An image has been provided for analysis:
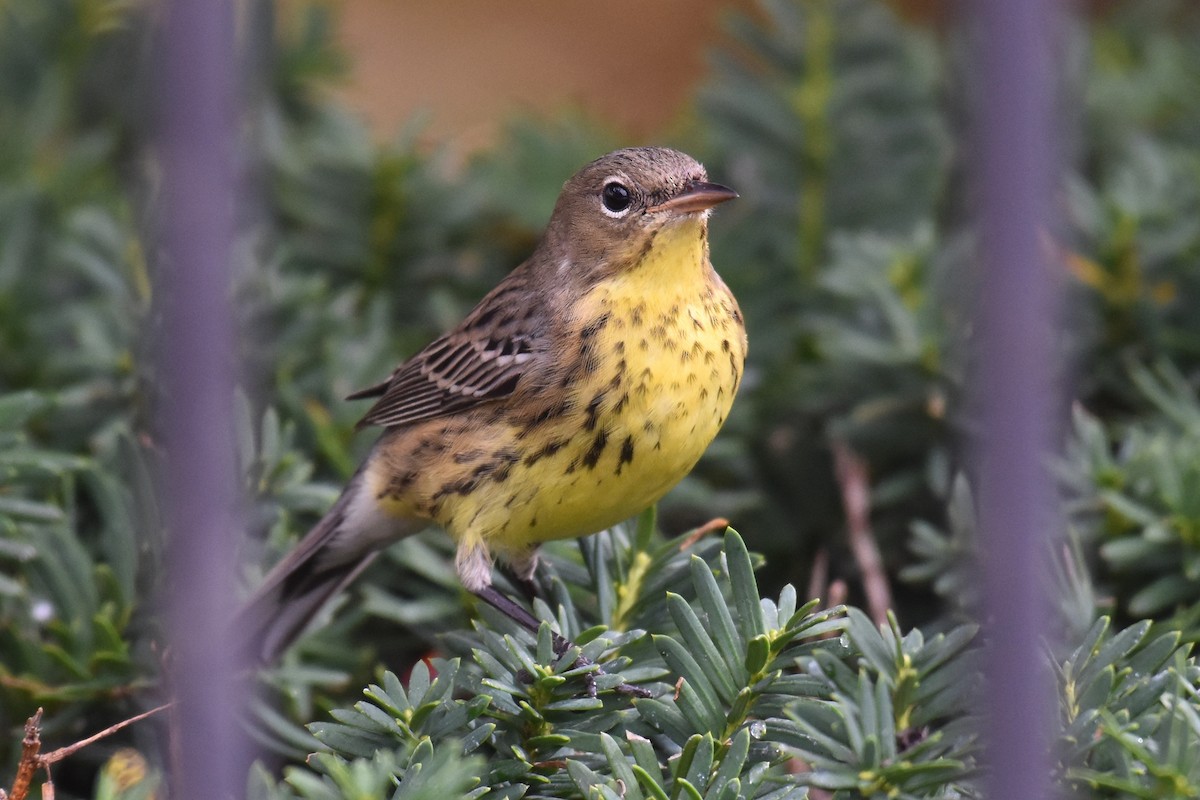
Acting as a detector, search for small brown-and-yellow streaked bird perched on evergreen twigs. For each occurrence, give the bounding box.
[238,148,746,662]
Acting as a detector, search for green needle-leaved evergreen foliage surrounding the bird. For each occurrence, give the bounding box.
[0,0,1200,800]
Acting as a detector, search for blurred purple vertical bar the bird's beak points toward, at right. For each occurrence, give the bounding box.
[968,0,1062,800]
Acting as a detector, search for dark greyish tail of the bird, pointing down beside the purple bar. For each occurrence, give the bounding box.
[234,474,413,664]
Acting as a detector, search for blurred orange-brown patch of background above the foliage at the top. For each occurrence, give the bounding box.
[293,0,940,150]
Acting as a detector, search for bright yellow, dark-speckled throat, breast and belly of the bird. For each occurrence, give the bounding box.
[372,219,746,555]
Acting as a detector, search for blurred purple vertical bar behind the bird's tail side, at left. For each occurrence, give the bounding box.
[157,0,246,798]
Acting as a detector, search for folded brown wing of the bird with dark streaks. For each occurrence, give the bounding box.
[349,276,546,428]
